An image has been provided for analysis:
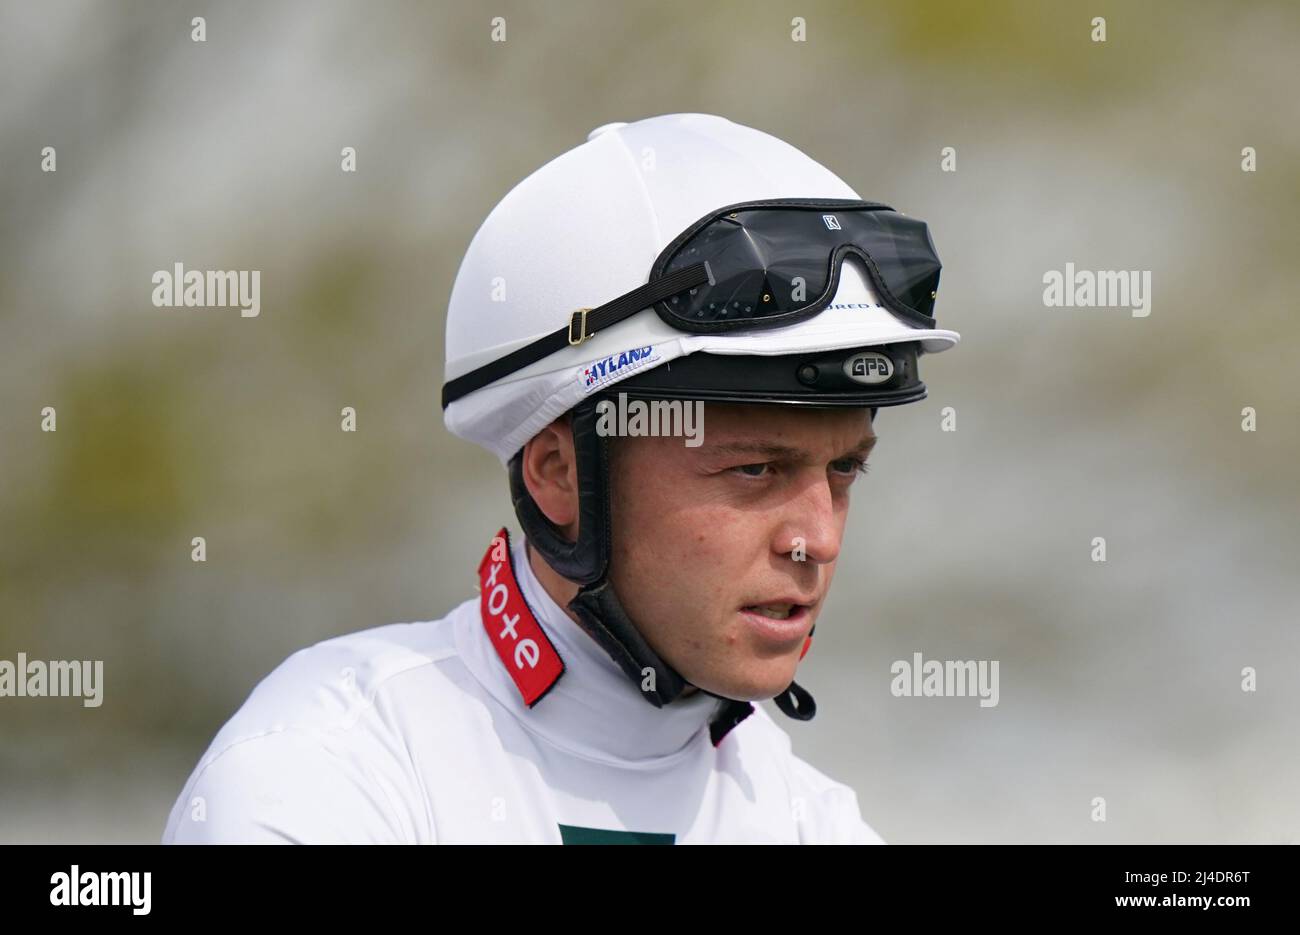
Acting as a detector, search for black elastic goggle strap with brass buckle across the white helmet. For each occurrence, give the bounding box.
[442,263,711,408]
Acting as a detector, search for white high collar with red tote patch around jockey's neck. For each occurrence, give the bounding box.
[456,529,724,766]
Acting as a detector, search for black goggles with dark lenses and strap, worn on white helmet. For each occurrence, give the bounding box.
[442,198,941,408]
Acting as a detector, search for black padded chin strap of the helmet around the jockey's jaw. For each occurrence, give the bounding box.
[510,395,816,745]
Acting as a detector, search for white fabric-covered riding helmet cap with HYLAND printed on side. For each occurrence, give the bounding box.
[443,113,961,463]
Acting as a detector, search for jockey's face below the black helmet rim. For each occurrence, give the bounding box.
[610,404,875,701]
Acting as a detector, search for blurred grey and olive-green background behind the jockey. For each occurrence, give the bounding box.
[0,0,1300,843]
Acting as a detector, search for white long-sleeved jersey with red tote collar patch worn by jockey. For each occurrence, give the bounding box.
[163,530,884,844]
